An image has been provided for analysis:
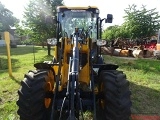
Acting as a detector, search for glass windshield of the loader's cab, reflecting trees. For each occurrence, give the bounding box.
[58,10,97,39]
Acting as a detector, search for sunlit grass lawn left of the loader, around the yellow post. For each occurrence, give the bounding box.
[0,46,51,120]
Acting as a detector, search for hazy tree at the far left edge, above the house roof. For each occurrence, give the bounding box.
[0,2,19,32]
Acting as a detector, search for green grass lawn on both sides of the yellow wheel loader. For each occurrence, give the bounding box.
[0,46,160,120]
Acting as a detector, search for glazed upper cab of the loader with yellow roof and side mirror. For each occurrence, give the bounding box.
[57,6,113,40]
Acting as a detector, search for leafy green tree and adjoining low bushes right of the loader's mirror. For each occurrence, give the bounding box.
[103,4,160,39]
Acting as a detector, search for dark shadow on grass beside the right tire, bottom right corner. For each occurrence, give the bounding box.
[130,82,160,115]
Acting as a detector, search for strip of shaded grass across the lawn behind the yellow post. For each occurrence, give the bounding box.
[0,46,46,55]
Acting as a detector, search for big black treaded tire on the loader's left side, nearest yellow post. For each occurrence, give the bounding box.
[17,70,55,120]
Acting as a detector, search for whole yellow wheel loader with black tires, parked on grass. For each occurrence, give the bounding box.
[17,6,131,120]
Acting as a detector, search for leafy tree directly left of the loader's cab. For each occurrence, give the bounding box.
[23,0,62,46]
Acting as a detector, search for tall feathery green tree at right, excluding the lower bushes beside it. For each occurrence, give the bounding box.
[124,4,160,38]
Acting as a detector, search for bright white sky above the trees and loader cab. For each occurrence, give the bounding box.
[0,0,160,27]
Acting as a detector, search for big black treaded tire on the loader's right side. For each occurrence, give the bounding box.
[100,70,132,120]
